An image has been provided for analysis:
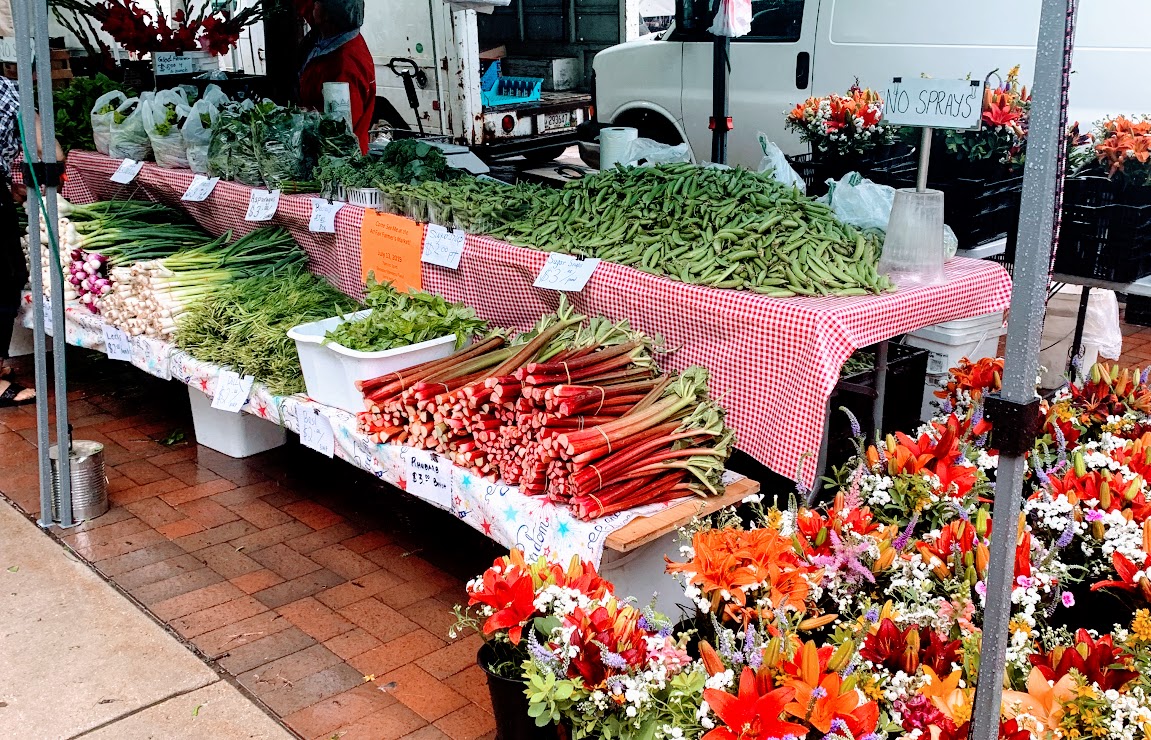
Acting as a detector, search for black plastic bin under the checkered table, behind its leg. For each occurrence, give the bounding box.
[826,341,929,472]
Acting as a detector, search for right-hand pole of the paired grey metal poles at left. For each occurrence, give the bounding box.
[28,0,74,527]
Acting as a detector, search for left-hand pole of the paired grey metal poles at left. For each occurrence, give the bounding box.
[12,0,54,527]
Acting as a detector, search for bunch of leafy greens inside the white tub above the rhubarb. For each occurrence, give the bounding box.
[323,277,487,352]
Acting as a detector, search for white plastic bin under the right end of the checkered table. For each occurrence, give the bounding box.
[904,312,1007,419]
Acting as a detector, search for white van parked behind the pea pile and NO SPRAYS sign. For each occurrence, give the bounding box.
[594,0,1151,167]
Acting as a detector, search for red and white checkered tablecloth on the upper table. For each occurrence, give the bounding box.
[66,152,1011,485]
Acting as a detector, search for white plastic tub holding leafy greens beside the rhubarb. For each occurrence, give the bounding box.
[288,308,456,413]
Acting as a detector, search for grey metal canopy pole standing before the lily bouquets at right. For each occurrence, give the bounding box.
[971,0,1075,740]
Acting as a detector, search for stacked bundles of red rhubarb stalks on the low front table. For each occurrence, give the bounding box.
[358,302,734,519]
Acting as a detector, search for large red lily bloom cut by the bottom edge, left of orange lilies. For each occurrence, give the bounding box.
[703,667,808,740]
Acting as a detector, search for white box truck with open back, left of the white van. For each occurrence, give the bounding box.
[363,0,640,160]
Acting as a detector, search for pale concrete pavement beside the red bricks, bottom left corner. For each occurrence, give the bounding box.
[0,504,295,740]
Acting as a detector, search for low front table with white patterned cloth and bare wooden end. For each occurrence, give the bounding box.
[22,293,760,610]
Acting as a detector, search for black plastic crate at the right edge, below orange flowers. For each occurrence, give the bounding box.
[1055,177,1151,283]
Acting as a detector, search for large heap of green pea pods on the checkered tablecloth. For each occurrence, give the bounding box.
[490,163,892,298]
